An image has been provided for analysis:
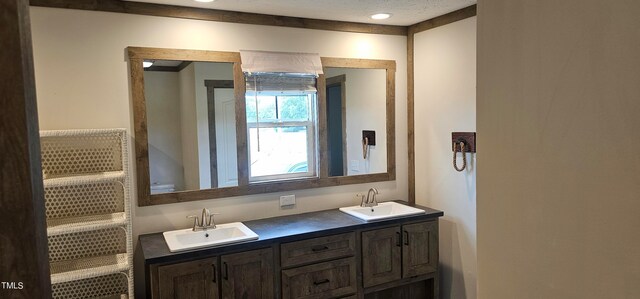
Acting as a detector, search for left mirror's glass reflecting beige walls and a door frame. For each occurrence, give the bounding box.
[144,60,238,194]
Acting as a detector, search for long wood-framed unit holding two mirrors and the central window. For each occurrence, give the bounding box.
[128,47,395,206]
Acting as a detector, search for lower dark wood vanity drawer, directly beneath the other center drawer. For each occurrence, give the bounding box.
[282,257,356,299]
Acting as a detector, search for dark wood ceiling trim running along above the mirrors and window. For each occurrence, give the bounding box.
[29,0,407,36]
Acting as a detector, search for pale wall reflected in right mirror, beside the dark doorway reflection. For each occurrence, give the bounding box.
[326,68,384,175]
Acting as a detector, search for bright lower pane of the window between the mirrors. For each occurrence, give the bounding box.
[249,126,309,177]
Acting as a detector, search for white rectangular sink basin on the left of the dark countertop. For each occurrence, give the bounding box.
[162,222,258,252]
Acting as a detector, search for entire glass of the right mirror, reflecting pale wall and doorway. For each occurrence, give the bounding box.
[325,67,387,176]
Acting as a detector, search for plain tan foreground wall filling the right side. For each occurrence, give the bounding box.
[477,0,640,299]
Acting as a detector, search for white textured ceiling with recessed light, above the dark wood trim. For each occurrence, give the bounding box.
[126,0,477,25]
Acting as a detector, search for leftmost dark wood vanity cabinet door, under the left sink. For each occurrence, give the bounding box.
[157,258,218,299]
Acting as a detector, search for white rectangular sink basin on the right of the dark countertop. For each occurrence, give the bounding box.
[340,202,425,221]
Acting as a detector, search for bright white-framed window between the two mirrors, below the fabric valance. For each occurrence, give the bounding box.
[246,73,317,182]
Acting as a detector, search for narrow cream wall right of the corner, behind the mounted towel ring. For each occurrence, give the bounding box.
[414,17,476,298]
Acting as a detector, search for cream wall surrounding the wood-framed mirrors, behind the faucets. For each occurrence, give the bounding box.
[31,7,407,246]
